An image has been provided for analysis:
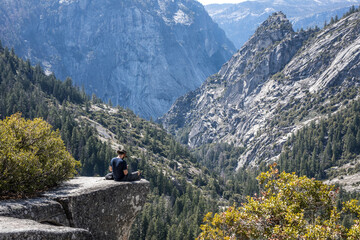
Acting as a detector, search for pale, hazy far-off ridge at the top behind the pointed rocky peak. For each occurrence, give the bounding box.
[205,0,360,49]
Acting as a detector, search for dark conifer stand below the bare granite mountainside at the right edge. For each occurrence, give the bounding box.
[279,94,360,179]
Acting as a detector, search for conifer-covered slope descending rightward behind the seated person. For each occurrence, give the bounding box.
[0,42,225,239]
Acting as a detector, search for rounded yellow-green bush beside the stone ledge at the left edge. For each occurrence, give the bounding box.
[0,113,79,198]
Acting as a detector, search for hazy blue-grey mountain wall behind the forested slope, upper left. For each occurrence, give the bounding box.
[0,0,235,118]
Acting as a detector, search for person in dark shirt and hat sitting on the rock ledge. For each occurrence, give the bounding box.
[105,150,141,182]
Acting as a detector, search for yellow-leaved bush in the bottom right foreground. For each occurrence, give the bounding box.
[198,164,360,239]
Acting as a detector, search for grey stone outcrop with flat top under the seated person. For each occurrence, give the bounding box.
[0,177,149,240]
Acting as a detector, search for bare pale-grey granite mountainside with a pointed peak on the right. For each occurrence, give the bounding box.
[162,12,360,167]
